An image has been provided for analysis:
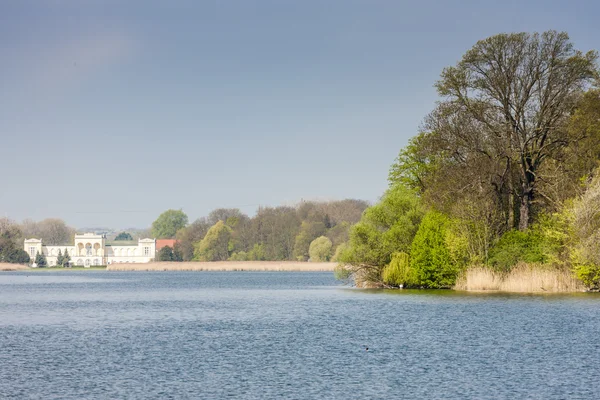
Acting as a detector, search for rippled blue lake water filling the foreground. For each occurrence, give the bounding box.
[0,271,600,399]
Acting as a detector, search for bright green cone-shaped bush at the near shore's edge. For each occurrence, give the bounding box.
[410,211,461,289]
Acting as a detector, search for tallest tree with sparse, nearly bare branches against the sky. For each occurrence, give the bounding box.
[434,31,598,230]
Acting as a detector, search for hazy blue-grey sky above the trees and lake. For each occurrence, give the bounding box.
[0,0,600,228]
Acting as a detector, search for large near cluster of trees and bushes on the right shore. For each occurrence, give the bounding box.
[338,31,600,288]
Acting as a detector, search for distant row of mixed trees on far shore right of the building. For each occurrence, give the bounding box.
[152,199,368,261]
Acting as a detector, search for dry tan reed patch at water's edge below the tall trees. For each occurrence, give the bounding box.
[454,264,585,293]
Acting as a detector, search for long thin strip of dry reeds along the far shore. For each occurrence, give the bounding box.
[106,261,337,272]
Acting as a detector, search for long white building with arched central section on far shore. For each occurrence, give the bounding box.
[24,233,156,267]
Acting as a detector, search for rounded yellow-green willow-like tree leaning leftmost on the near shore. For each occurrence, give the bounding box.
[338,185,424,282]
